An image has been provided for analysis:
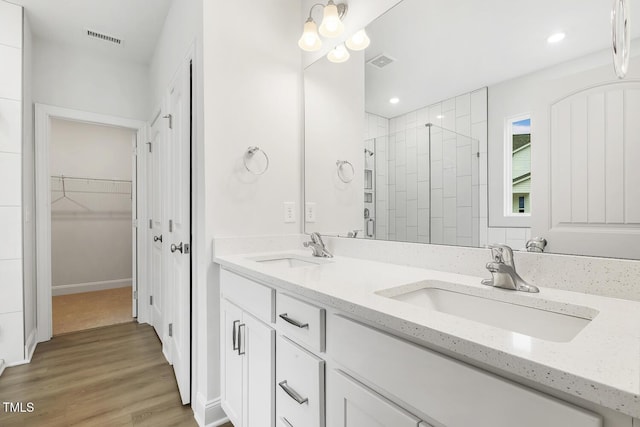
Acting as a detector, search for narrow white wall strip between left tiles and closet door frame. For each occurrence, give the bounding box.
[22,10,36,358]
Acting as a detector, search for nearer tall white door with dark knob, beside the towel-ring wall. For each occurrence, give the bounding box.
[165,61,191,404]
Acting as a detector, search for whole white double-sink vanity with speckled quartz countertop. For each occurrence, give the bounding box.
[215,250,640,427]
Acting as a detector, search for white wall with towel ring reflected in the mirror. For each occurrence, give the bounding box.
[304,52,364,236]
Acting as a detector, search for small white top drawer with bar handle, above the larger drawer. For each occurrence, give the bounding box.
[276,293,325,352]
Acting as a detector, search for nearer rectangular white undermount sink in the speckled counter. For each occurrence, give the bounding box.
[378,282,597,342]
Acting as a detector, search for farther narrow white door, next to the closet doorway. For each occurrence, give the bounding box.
[147,113,164,347]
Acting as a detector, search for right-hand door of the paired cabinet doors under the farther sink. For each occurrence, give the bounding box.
[240,312,276,427]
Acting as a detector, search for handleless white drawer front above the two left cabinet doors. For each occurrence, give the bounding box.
[220,268,275,323]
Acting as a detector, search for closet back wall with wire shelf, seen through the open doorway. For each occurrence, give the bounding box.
[50,119,134,294]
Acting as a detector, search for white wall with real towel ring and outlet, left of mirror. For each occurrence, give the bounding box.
[202,0,302,422]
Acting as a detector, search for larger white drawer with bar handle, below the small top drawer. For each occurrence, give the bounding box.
[276,336,325,427]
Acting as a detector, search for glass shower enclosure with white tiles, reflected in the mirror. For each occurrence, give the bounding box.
[365,124,480,246]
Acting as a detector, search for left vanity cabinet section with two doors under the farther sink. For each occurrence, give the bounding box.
[220,272,275,427]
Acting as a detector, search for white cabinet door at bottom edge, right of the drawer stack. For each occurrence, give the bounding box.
[327,371,427,427]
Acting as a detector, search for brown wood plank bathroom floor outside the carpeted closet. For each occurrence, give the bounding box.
[0,322,197,427]
